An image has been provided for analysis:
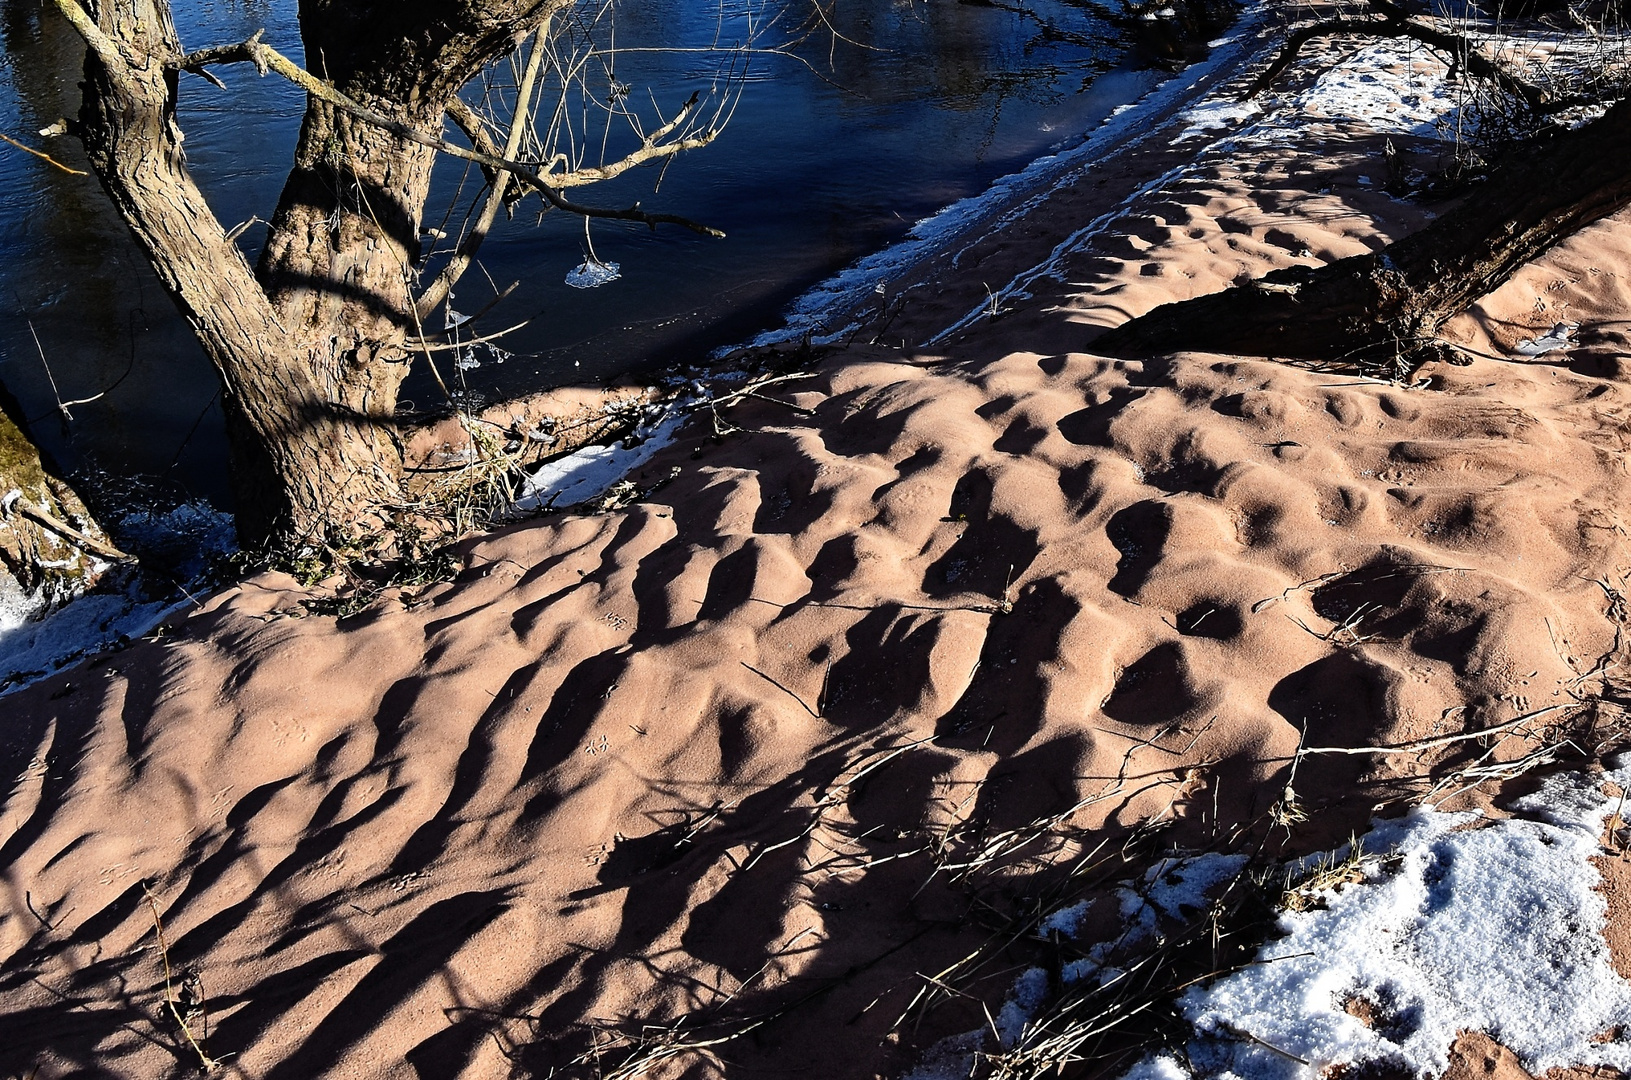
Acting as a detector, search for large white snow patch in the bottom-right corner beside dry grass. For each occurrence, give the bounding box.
[1129,767,1631,1080]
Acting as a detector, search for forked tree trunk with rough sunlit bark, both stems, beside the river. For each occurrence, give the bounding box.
[59,0,571,545]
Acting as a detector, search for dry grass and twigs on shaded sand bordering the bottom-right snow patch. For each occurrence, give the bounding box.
[902,681,1631,1080]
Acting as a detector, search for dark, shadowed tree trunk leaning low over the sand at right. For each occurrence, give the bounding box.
[1093,101,1631,370]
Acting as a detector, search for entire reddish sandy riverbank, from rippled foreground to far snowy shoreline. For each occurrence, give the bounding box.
[0,8,1631,1080]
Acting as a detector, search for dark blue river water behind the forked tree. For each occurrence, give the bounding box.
[0,0,1226,506]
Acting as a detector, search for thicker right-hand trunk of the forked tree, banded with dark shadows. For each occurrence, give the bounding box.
[238,0,569,541]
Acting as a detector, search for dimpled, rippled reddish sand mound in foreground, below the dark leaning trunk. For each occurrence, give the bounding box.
[0,332,1626,1077]
